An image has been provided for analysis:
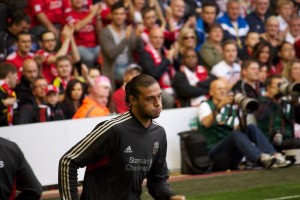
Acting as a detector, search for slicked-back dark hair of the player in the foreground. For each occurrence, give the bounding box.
[125,74,157,107]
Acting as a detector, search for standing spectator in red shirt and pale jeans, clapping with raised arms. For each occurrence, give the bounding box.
[64,0,102,67]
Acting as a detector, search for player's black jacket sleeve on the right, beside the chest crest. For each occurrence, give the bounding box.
[147,132,175,200]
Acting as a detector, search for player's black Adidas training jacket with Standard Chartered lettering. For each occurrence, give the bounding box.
[59,111,174,200]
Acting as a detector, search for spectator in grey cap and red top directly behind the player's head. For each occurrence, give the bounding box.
[112,64,142,114]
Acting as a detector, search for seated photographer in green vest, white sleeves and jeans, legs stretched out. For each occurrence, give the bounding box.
[198,79,290,170]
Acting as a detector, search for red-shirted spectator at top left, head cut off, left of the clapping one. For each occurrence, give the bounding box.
[27,0,70,37]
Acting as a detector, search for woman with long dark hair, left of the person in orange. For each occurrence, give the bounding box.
[62,79,85,119]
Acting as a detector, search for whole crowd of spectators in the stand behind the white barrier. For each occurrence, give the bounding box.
[0,0,300,152]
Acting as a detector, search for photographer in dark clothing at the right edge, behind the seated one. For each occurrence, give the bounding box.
[255,75,300,151]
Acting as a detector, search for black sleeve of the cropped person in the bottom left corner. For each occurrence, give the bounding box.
[16,147,43,200]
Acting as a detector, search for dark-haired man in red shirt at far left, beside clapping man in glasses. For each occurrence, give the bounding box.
[6,32,34,80]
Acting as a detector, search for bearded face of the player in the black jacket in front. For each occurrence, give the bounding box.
[131,83,162,120]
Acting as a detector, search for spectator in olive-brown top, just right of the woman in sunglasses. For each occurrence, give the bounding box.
[199,24,223,69]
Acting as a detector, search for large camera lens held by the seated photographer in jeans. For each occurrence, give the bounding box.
[233,93,259,113]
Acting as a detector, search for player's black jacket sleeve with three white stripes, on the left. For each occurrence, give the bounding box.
[58,121,116,200]
